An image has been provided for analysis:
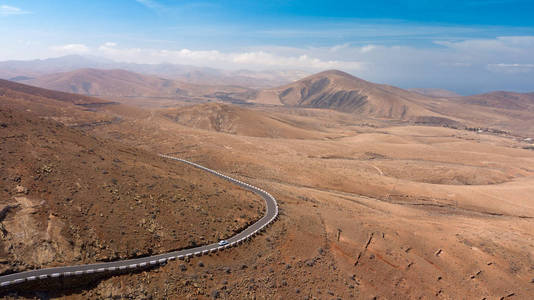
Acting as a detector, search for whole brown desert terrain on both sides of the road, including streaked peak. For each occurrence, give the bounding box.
[0,71,534,299]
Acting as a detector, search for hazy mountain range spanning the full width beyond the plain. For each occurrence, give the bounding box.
[2,57,534,134]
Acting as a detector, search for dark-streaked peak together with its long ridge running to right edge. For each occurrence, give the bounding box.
[252,70,534,135]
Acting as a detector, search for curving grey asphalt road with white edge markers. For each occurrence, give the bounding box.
[0,154,278,289]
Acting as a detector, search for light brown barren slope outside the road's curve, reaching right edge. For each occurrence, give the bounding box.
[79,107,534,299]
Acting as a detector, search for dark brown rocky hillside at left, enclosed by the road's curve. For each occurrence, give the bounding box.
[0,82,263,273]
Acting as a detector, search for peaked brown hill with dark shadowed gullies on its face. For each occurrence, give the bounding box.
[255,70,438,119]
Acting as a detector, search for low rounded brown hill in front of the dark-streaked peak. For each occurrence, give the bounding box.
[160,103,321,139]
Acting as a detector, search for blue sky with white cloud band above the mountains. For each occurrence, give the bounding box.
[0,0,534,94]
